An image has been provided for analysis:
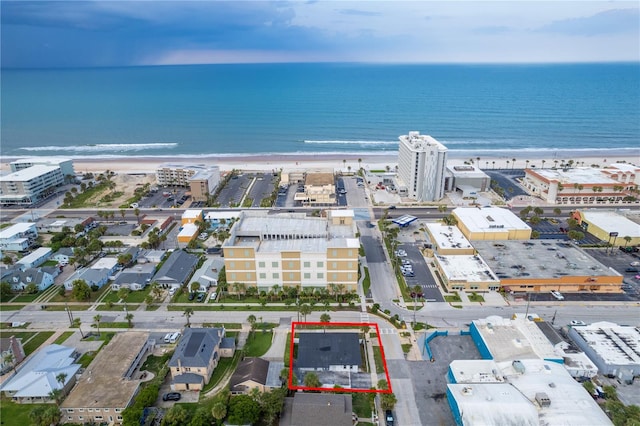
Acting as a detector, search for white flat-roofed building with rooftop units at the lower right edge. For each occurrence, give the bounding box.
[569,321,640,380]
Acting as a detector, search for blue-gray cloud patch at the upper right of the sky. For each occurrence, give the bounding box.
[537,9,640,37]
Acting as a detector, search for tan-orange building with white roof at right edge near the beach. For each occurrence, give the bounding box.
[522,163,640,205]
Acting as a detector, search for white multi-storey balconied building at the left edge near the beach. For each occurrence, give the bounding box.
[0,164,65,206]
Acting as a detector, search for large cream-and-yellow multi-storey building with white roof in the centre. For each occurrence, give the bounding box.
[222,210,360,293]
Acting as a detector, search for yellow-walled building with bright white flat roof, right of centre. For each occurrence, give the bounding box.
[451,207,531,241]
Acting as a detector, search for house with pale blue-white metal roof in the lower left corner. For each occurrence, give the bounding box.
[0,344,81,403]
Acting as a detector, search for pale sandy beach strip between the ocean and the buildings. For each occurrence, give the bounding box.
[0,148,640,173]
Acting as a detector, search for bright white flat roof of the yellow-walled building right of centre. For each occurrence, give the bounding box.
[452,207,531,232]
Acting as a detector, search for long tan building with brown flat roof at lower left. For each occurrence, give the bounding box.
[60,331,153,424]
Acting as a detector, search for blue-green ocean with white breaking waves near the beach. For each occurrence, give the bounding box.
[0,63,640,158]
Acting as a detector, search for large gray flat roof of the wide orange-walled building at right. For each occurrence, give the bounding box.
[473,240,620,279]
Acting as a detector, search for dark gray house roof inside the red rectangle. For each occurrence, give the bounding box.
[295,333,362,372]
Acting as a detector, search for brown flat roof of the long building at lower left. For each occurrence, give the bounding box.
[61,331,149,408]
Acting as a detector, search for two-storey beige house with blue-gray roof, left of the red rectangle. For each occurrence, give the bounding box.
[169,328,233,391]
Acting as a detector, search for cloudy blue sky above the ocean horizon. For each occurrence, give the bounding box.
[0,0,640,68]
